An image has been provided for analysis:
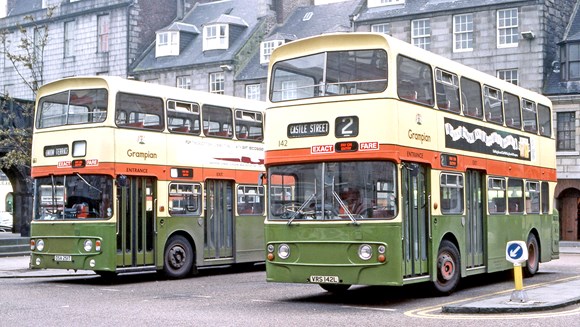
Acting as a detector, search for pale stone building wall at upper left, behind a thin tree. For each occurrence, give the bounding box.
[0,0,192,99]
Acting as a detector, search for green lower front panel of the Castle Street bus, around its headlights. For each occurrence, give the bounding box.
[266,224,403,285]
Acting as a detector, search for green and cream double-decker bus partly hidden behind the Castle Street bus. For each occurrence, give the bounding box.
[30,76,265,278]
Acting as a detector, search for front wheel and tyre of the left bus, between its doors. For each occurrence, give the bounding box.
[163,235,194,279]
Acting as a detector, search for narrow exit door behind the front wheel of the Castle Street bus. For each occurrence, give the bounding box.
[465,170,485,268]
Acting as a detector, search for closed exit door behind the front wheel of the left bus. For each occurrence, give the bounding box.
[204,180,234,259]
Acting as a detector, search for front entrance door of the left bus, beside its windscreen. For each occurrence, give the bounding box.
[117,176,157,267]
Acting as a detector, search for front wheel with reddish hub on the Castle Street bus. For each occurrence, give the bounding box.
[433,240,461,294]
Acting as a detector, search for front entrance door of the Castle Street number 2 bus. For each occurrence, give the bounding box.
[401,162,429,278]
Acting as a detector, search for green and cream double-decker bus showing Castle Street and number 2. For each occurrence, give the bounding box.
[265,33,559,293]
